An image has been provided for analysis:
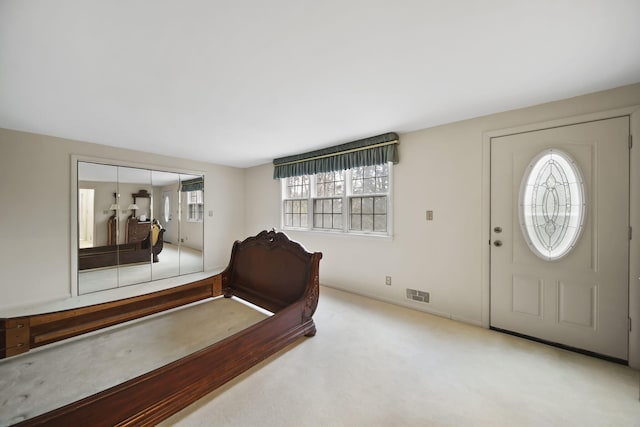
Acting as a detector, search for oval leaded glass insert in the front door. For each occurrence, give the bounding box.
[519,148,585,261]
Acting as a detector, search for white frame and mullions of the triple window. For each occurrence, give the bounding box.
[280,162,393,237]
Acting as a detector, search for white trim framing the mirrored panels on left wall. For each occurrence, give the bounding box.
[69,154,207,298]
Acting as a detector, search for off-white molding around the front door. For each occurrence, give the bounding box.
[480,105,640,369]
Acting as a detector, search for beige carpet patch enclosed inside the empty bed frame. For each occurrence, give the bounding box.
[0,297,268,426]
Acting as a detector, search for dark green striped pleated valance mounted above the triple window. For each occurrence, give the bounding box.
[273,132,399,179]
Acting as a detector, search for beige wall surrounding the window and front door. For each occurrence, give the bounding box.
[245,84,640,364]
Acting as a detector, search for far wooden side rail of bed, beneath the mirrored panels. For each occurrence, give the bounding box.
[0,274,222,359]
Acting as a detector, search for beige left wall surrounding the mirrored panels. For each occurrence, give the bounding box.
[0,129,244,309]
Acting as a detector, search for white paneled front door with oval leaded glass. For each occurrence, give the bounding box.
[490,117,629,360]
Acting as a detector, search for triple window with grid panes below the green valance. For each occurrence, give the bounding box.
[282,163,392,235]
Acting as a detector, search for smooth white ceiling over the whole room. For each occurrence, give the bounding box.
[0,0,640,167]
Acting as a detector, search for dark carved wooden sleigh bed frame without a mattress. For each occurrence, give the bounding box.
[0,231,322,426]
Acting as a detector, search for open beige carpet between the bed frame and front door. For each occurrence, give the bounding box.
[163,287,640,427]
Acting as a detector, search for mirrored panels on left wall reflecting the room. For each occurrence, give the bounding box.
[77,161,204,294]
